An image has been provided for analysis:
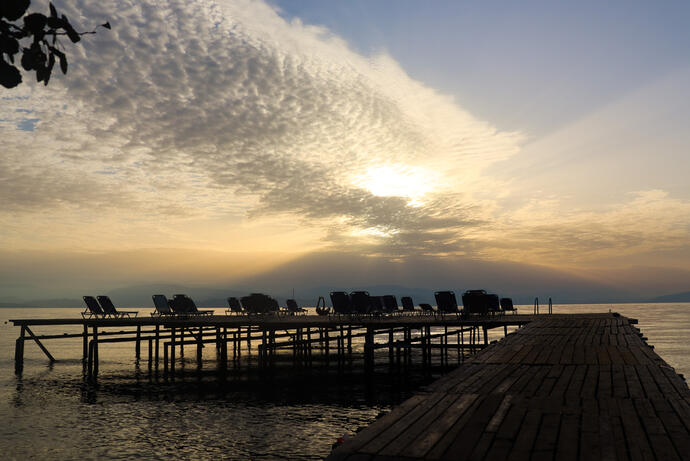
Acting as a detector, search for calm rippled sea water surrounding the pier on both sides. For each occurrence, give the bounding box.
[0,303,690,460]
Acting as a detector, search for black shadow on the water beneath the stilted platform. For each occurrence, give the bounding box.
[79,348,453,407]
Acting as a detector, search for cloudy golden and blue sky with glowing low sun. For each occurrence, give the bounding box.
[0,0,690,300]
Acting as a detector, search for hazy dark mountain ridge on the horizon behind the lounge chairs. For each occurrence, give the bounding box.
[0,253,690,308]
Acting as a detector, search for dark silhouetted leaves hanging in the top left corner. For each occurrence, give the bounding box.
[0,0,110,88]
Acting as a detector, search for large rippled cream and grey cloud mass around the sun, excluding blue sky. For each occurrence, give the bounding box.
[0,0,688,266]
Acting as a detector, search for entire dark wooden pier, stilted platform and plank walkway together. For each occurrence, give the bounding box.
[12,314,690,461]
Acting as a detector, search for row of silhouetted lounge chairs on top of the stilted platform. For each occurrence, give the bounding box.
[82,290,517,318]
